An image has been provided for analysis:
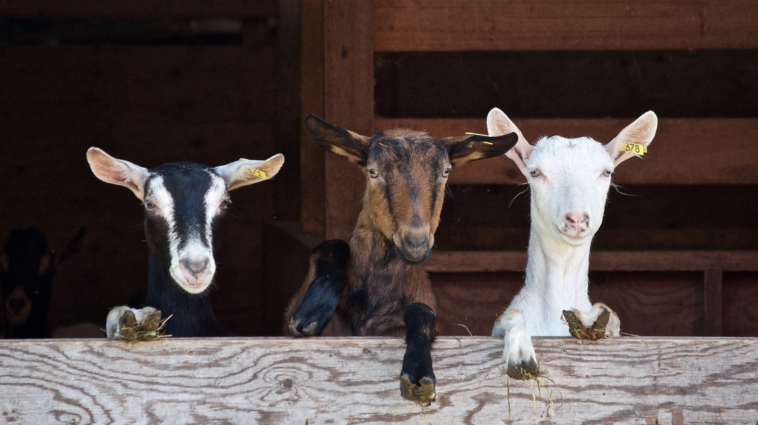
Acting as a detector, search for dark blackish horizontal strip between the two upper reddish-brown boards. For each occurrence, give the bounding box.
[374,49,758,119]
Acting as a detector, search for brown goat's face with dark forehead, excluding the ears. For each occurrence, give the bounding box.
[365,130,452,263]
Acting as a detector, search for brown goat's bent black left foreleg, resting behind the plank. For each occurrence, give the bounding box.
[288,239,350,336]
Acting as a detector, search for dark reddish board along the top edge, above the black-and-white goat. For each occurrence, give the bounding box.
[0,0,277,18]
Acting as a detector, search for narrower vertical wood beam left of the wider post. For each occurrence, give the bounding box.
[299,0,325,234]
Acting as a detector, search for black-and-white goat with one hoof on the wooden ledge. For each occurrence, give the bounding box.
[87,148,284,337]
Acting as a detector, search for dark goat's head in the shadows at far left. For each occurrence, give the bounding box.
[0,229,55,326]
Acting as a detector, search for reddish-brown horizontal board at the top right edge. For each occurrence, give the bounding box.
[374,0,758,51]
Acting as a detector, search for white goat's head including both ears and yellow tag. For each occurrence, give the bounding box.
[487,108,658,246]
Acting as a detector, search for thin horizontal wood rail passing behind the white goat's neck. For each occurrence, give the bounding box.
[422,251,758,273]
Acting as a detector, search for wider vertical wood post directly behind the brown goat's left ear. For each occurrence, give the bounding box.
[324,0,374,239]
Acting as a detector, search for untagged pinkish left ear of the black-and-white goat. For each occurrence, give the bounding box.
[87,148,150,201]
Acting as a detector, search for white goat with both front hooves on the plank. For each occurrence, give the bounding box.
[487,108,658,378]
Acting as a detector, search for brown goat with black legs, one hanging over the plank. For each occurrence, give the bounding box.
[287,115,518,404]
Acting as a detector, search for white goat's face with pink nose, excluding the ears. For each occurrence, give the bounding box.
[525,136,614,245]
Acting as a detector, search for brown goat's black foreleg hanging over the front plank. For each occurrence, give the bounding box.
[400,303,437,405]
